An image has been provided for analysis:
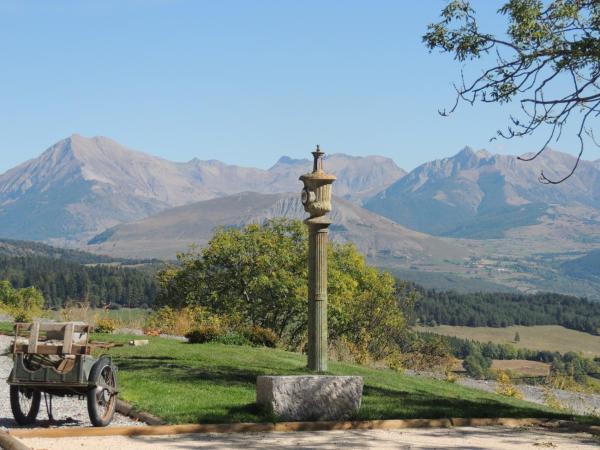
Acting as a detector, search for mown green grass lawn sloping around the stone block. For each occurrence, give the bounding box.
[96,335,580,423]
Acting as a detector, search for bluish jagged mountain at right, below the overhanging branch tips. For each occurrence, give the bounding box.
[365,148,600,238]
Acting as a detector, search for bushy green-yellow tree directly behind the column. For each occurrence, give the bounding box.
[157,219,406,359]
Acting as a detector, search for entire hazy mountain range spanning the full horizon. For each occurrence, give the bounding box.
[0,135,600,297]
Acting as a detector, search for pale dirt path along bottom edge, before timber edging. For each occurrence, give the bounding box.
[16,427,600,450]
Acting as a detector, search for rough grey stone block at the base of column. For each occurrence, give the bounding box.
[256,375,363,421]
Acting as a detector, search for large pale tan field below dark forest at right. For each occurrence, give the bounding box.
[415,325,600,357]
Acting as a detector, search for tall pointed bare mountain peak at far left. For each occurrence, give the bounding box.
[0,135,212,240]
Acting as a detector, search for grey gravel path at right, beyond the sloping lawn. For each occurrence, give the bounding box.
[457,378,600,415]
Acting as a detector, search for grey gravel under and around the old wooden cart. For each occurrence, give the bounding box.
[0,335,144,429]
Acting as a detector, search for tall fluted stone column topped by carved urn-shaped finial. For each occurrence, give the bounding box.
[300,146,335,372]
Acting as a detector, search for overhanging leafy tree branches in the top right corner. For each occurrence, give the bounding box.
[423,0,600,184]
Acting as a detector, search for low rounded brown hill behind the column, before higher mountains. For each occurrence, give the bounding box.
[87,192,468,263]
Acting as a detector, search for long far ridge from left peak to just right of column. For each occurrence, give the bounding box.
[0,135,404,242]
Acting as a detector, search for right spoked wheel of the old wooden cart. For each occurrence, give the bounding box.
[87,357,117,427]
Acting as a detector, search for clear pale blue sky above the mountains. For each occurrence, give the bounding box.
[0,0,600,172]
